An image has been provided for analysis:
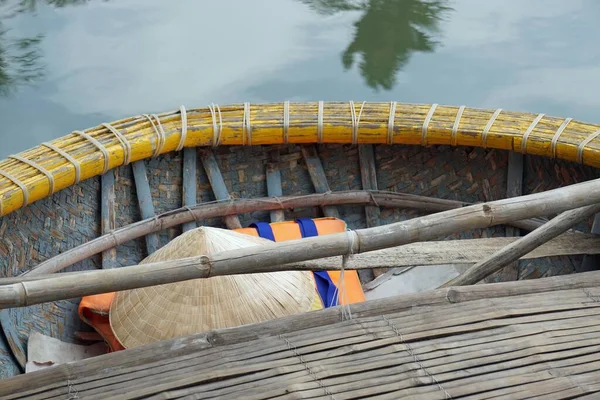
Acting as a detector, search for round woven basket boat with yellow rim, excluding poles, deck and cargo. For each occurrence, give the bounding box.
[0,102,600,377]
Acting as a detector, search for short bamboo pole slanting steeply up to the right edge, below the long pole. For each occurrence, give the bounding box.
[444,204,600,286]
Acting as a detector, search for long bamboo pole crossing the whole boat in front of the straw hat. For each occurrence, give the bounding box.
[5,179,600,308]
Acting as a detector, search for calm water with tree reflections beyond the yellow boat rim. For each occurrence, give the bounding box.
[0,0,600,157]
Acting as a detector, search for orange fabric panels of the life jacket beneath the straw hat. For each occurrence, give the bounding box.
[79,218,365,351]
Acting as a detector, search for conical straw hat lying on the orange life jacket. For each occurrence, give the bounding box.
[110,227,322,348]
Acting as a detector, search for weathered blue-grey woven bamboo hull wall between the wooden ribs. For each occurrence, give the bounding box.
[0,102,599,377]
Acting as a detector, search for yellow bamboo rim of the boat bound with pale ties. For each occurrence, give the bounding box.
[0,101,600,216]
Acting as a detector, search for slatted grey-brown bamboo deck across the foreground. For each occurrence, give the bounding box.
[0,272,600,400]
